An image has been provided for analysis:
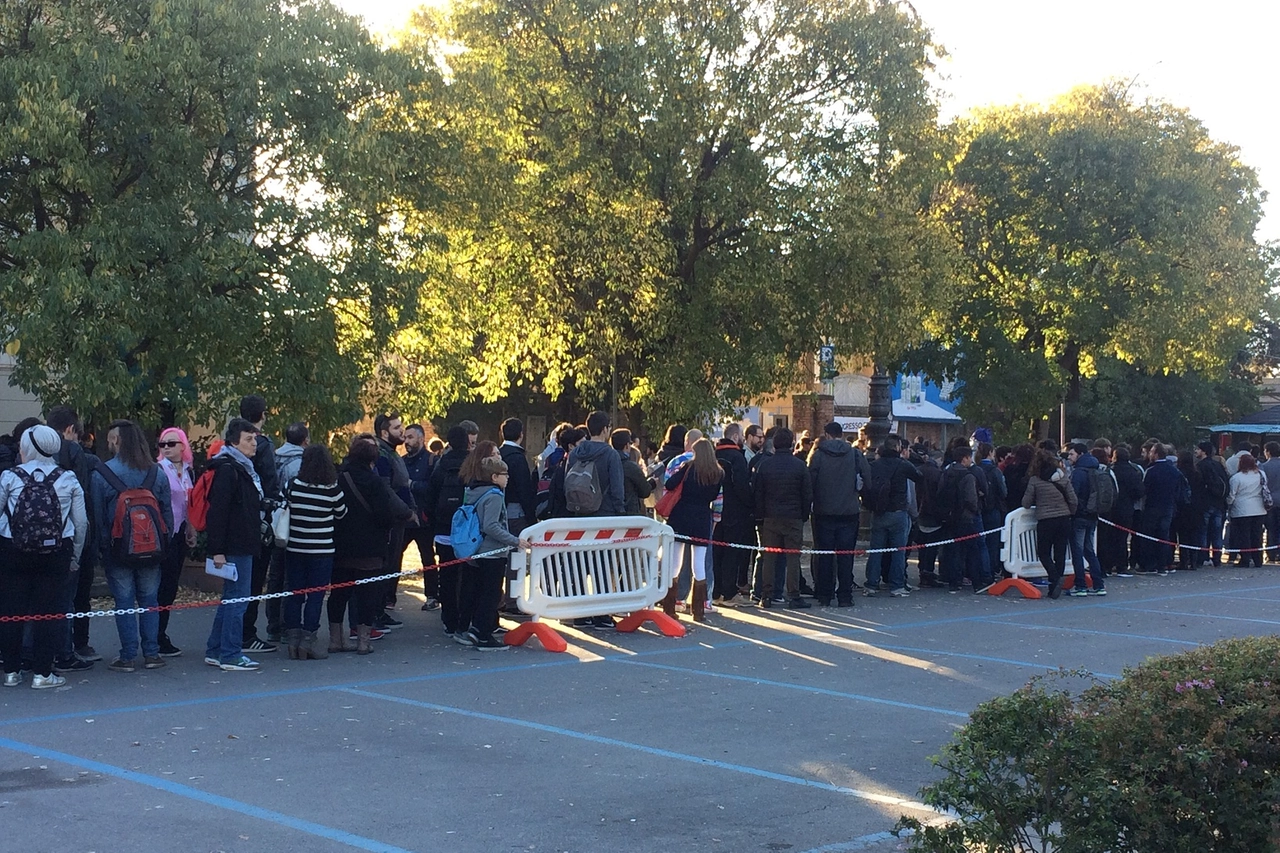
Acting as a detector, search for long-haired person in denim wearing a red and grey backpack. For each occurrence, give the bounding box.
[90,420,173,672]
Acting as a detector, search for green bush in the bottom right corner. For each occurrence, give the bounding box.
[899,637,1280,853]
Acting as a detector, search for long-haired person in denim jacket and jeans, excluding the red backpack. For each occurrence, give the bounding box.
[92,420,173,672]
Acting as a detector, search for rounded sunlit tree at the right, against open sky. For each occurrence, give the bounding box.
[911,86,1267,435]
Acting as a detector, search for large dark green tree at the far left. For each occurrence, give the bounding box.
[0,0,417,427]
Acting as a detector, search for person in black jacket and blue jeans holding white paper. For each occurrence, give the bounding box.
[205,418,267,672]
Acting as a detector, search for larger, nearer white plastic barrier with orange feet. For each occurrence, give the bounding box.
[506,515,685,651]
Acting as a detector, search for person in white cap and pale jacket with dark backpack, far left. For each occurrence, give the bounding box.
[0,425,88,690]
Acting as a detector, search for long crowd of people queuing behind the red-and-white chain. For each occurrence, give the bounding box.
[0,394,1264,689]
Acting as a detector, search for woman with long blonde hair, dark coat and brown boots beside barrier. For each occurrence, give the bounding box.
[662,438,724,622]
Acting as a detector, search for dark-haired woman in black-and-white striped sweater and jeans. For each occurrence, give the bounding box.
[284,444,347,661]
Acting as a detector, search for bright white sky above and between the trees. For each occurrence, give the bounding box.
[335,0,1280,240]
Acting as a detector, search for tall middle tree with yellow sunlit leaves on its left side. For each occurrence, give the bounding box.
[402,0,940,418]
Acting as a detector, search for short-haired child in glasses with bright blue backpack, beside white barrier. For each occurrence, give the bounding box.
[449,456,529,652]
